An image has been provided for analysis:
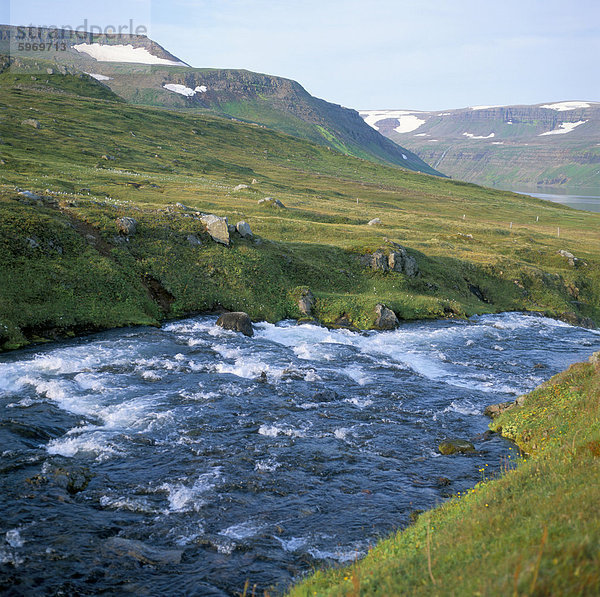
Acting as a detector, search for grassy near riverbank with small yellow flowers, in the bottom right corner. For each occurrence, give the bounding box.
[290,353,600,597]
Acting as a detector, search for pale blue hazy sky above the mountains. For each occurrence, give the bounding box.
[5,0,600,110]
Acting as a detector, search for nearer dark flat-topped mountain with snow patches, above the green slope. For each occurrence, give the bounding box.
[0,25,439,175]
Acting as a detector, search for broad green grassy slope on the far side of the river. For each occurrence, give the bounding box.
[0,72,600,348]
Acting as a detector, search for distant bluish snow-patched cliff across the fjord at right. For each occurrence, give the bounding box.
[360,101,600,192]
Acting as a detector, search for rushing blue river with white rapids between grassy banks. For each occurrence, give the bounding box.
[0,313,600,595]
